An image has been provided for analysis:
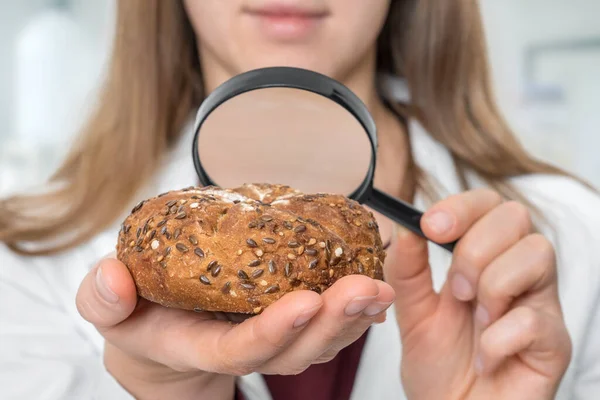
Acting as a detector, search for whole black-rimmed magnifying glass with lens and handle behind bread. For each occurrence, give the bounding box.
[192,67,455,251]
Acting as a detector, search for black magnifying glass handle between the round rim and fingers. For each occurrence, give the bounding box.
[366,188,456,252]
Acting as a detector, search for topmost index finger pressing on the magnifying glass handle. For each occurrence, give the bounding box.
[421,189,502,243]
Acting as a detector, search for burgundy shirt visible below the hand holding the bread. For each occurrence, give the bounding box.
[235,330,369,400]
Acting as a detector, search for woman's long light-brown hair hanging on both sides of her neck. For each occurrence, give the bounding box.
[0,0,592,255]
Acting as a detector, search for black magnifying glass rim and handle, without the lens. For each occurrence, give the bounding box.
[192,67,456,252]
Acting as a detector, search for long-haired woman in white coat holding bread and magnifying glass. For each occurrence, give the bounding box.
[0,0,600,399]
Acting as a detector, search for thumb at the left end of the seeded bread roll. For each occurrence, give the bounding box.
[75,258,137,329]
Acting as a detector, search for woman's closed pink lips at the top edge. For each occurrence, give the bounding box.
[243,1,329,41]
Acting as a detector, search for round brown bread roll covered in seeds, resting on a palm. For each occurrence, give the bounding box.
[117,185,385,314]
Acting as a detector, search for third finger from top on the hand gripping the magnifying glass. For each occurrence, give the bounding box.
[475,234,560,327]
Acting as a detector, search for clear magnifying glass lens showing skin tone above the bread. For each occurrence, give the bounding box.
[197,87,371,195]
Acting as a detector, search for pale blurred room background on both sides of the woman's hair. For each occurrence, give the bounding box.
[0,0,600,196]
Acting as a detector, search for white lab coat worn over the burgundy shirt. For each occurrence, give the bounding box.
[0,81,600,400]
